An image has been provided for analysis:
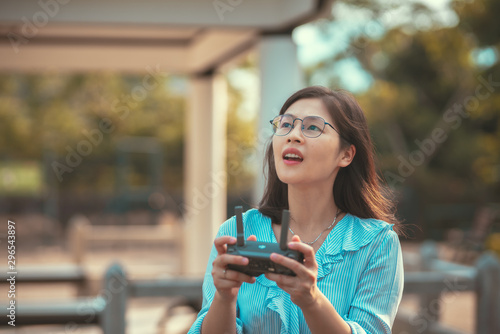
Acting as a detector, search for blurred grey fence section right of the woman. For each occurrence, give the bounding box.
[394,241,500,334]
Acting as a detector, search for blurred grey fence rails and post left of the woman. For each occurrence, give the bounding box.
[0,264,202,334]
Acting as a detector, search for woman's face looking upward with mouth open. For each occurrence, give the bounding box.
[273,98,354,186]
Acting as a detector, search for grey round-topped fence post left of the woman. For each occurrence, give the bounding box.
[100,263,128,334]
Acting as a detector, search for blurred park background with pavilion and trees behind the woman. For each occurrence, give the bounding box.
[0,0,500,333]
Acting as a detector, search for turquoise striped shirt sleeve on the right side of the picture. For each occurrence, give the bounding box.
[344,230,404,334]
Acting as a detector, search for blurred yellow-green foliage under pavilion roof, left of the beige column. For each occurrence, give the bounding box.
[0,73,185,193]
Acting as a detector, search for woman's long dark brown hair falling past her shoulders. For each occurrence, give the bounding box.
[259,86,402,233]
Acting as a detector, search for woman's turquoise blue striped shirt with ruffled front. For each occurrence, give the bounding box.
[189,209,403,334]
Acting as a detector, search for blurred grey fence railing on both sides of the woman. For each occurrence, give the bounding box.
[3,242,500,334]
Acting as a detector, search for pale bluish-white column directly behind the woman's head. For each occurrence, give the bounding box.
[253,35,304,204]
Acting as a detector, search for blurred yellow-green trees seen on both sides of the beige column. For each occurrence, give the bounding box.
[0,65,257,210]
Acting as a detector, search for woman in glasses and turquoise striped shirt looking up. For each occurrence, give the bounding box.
[190,87,403,334]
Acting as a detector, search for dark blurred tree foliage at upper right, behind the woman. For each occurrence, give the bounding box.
[307,0,500,235]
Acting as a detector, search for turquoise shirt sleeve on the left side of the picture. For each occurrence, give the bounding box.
[188,218,243,334]
